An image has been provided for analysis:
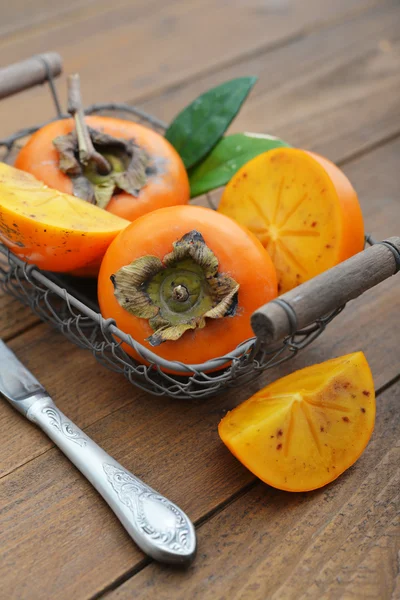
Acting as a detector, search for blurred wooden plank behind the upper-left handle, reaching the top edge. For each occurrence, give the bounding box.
[0,0,378,135]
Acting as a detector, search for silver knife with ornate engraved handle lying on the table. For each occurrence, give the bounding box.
[0,340,196,564]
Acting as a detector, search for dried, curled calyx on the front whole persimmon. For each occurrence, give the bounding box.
[111,230,239,346]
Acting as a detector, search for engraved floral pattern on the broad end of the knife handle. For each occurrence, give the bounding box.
[103,463,193,554]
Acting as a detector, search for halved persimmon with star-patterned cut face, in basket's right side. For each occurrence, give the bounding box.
[218,148,364,293]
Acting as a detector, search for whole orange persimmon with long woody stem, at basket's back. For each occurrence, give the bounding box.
[15,75,190,221]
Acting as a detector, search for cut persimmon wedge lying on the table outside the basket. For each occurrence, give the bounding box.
[218,352,375,492]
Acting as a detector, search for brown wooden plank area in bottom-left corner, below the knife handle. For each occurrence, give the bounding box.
[0,450,142,600]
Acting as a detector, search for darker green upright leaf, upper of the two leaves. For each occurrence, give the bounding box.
[165,77,257,169]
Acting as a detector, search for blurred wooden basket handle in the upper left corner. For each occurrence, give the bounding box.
[0,52,62,100]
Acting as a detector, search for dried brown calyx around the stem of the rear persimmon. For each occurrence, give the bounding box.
[53,127,150,208]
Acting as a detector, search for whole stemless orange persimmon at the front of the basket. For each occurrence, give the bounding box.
[98,206,277,364]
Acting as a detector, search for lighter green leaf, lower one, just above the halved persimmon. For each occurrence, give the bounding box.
[189,133,289,198]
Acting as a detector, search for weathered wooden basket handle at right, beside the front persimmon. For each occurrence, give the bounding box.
[251,237,400,344]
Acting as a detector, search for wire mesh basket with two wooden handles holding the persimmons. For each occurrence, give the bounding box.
[0,54,400,399]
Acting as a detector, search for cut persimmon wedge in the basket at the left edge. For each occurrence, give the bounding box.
[0,163,129,272]
